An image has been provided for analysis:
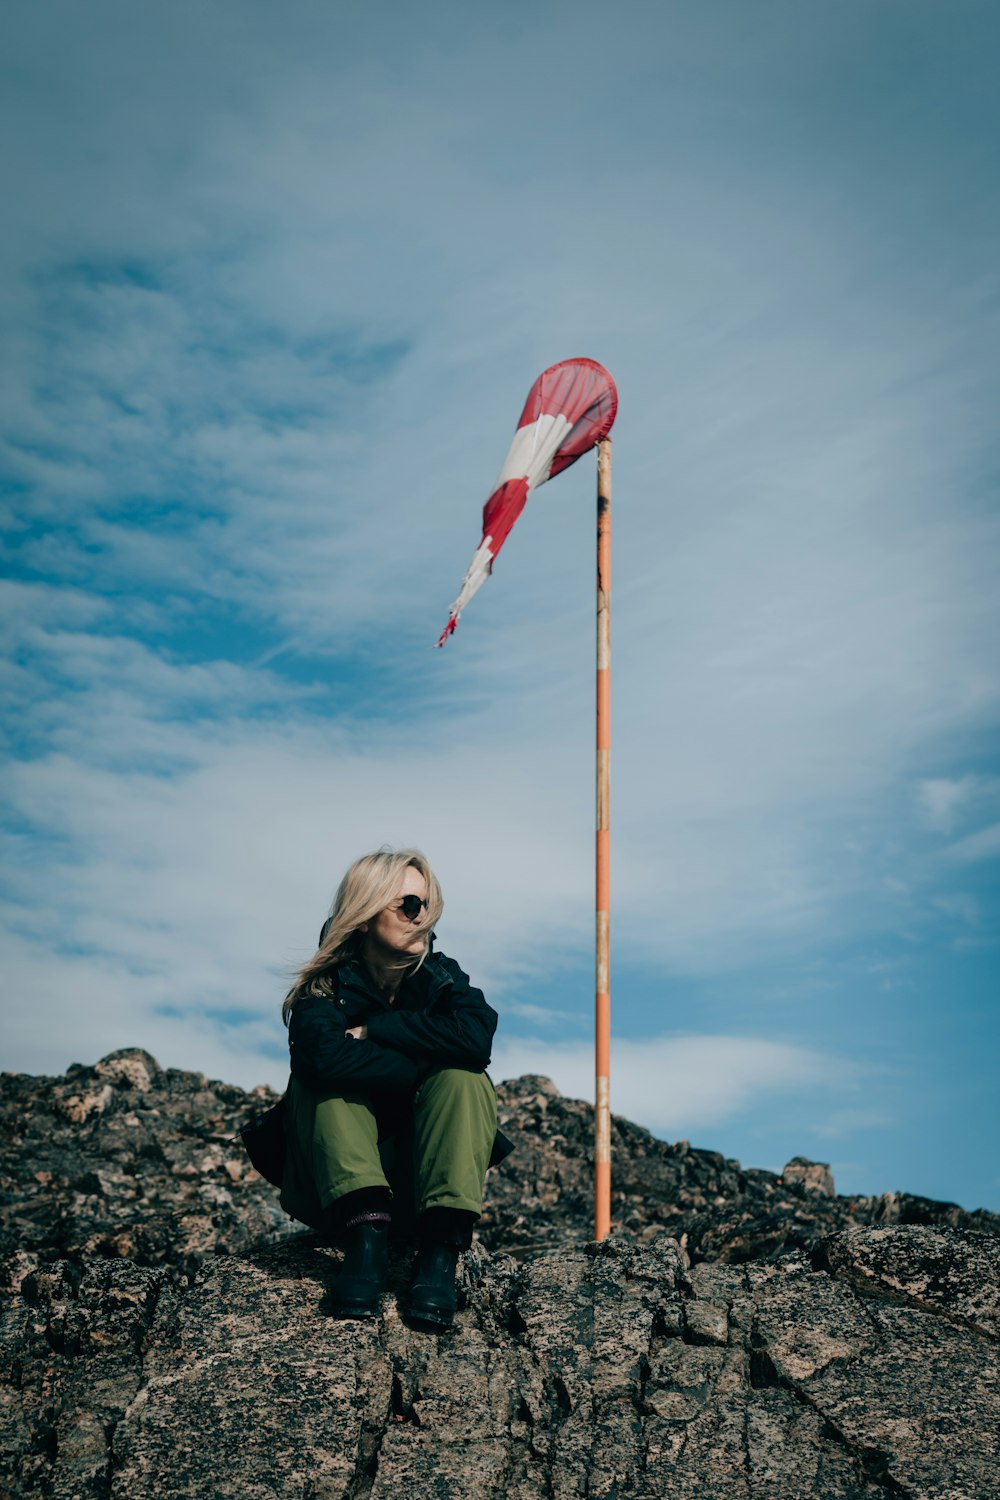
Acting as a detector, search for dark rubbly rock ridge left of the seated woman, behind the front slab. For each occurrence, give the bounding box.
[0,1049,288,1286]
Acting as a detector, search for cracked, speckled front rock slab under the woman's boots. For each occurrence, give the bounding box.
[0,1227,1000,1500]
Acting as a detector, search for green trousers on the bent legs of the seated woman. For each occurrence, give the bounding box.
[280,1068,496,1227]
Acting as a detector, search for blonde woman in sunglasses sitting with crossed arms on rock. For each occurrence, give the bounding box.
[280,849,507,1328]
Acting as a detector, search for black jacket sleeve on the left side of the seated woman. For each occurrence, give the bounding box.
[288,996,418,1094]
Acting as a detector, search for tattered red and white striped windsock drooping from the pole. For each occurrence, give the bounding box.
[438,360,618,647]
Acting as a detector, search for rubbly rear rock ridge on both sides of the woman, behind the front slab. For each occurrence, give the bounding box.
[0,1049,1000,1289]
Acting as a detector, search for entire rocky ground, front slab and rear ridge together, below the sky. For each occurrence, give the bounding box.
[0,1052,1000,1500]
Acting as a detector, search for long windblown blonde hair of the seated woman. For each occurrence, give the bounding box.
[282,845,444,1025]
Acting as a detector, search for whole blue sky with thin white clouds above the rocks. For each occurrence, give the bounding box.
[0,0,1000,1209]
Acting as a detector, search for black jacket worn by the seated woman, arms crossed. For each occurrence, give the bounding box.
[288,953,496,1094]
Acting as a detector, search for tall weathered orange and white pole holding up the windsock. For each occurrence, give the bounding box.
[594,438,612,1239]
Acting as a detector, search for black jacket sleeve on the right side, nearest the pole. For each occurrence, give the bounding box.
[367,954,496,1073]
